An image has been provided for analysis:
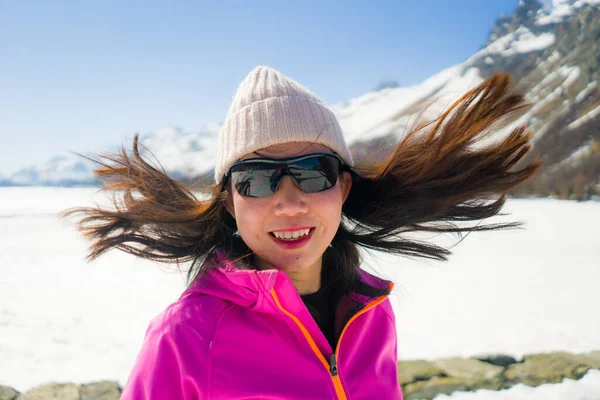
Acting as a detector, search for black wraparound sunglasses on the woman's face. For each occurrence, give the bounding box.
[224,153,344,198]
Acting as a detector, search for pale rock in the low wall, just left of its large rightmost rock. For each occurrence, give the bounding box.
[435,358,504,390]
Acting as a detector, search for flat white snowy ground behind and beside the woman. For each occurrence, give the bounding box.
[0,188,600,400]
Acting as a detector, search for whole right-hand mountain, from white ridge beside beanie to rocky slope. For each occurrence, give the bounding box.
[336,0,600,198]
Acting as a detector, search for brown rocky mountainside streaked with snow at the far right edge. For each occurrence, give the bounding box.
[474,0,600,198]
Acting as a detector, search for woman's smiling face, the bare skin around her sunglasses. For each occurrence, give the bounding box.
[226,143,352,272]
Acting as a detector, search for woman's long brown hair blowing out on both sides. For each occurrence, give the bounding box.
[63,74,539,291]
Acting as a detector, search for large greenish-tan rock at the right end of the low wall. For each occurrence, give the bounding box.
[504,352,594,386]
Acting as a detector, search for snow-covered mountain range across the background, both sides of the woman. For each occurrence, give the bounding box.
[5,0,600,197]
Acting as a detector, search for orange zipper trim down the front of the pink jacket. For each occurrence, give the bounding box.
[271,283,394,400]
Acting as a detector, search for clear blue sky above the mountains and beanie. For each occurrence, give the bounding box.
[0,0,518,174]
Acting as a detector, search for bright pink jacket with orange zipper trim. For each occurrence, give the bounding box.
[121,255,402,400]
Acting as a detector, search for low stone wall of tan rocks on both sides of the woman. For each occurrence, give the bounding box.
[0,350,600,400]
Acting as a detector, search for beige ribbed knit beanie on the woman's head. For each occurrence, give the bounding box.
[215,67,352,183]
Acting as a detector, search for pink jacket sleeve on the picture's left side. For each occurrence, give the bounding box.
[121,318,210,400]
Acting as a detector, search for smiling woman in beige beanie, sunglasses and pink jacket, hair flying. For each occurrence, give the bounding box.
[65,67,537,400]
